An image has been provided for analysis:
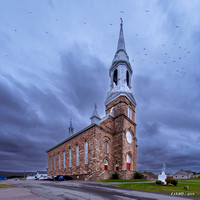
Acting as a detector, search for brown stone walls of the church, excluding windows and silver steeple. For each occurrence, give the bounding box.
[48,96,137,180]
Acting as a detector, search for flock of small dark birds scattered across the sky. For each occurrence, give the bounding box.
[6,10,191,75]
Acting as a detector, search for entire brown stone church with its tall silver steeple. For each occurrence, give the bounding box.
[47,22,137,180]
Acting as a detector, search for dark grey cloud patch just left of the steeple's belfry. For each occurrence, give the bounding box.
[55,45,108,117]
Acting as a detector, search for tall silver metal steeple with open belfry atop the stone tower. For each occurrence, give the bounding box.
[105,19,136,106]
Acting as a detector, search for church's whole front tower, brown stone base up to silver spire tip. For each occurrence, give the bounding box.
[105,19,137,173]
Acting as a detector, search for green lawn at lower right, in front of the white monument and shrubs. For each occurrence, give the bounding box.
[117,183,200,197]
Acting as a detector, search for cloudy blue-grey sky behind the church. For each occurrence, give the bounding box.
[0,0,200,173]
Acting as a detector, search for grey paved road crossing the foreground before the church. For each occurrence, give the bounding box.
[0,181,198,200]
